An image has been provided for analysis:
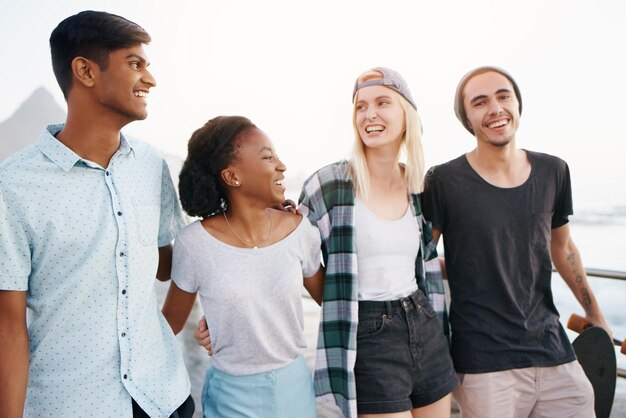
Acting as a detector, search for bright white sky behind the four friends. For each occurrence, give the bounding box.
[0,0,626,208]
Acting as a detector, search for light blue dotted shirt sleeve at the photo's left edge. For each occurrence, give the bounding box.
[0,190,31,291]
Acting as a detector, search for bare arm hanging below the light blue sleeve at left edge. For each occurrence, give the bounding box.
[0,290,29,418]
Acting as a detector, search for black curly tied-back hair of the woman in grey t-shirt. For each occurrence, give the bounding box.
[178,116,256,218]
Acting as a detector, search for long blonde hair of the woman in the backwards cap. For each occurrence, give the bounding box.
[350,71,424,199]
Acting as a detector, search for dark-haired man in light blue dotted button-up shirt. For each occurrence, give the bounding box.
[0,11,194,418]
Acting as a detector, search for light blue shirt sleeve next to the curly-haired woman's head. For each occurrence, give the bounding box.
[158,160,185,247]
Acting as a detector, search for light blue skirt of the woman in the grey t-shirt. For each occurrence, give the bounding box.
[202,356,315,418]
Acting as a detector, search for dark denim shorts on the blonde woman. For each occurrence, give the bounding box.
[354,290,458,414]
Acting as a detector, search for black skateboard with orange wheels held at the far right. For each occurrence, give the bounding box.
[568,317,622,418]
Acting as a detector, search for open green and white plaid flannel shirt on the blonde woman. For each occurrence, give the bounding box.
[299,160,448,418]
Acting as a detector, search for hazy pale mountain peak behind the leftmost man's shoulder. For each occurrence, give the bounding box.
[0,87,65,161]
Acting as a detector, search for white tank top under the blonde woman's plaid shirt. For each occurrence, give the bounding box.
[355,198,420,301]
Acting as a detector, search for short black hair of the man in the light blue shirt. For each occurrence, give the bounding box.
[50,10,151,99]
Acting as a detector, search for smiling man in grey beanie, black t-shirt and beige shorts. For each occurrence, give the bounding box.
[423,67,610,418]
